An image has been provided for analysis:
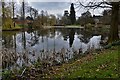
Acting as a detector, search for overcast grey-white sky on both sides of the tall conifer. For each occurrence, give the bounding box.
[29,2,103,17]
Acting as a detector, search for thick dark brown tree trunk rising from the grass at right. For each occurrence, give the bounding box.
[108,2,119,43]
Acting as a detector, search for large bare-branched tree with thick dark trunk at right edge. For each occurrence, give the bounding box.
[77,0,120,42]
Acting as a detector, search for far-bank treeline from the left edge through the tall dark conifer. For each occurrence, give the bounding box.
[2,2,76,28]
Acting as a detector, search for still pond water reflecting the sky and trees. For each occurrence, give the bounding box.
[2,28,105,69]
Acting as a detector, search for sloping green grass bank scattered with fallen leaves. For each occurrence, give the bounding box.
[47,47,119,78]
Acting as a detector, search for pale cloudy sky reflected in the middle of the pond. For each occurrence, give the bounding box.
[16,32,80,52]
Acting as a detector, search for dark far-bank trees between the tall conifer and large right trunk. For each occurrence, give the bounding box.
[76,9,120,25]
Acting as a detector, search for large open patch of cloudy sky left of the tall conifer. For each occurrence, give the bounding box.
[29,2,70,15]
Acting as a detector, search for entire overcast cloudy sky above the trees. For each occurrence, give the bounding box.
[1,0,108,17]
